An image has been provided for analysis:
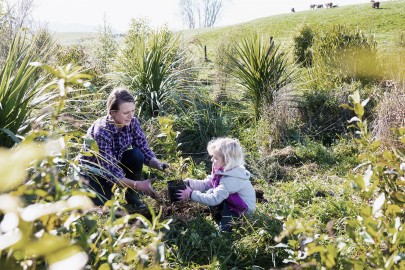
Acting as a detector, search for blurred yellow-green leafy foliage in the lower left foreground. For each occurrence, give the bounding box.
[0,63,170,269]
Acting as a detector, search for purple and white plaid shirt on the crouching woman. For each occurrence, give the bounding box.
[81,116,155,181]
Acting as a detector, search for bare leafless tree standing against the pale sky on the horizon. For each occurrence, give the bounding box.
[179,0,223,28]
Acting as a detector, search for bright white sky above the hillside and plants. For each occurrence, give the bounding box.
[8,0,384,32]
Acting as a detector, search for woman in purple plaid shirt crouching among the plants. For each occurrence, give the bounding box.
[80,88,169,209]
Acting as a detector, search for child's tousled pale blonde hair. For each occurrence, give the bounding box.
[207,138,245,171]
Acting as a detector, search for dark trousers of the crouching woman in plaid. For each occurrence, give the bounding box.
[89,148,144,205]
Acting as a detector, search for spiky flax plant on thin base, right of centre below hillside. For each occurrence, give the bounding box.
[229,33,294,121]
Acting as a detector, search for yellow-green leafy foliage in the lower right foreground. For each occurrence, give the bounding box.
[277,92,405,269]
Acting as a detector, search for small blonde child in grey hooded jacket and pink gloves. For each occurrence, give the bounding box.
[177,138,256,231]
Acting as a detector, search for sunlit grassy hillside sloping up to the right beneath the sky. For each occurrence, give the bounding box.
[183,1,405,51]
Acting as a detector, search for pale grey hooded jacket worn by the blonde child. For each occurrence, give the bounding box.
[189,166,256,214]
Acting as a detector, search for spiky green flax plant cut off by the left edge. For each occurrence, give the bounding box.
[0,34,50,147]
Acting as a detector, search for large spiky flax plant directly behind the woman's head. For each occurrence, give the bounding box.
[115,22,182,119]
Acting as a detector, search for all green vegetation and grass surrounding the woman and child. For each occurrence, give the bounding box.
[0,1,405,270]
